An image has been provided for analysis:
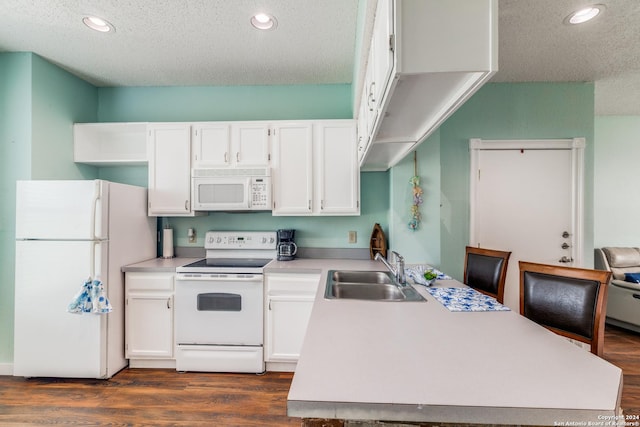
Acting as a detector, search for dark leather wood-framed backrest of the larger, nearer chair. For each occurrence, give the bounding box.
[519,261,611,356]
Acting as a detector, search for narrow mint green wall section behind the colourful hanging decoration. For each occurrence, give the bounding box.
[389,131,441,267]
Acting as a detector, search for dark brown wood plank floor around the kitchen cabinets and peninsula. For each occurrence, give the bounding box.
[0,325,640,427]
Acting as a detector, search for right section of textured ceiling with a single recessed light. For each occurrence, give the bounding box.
[493,0,640,115]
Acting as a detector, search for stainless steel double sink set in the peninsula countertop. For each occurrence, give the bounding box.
[324,270,426,302]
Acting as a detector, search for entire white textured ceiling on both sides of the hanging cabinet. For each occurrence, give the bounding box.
[0,0,640,115]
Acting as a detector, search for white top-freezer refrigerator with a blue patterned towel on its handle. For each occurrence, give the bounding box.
[13,180,156,378]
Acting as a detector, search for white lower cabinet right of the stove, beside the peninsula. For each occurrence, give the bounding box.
[264,273,320,372]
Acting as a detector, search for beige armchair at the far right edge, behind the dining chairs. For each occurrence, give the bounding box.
[594,247,640,332]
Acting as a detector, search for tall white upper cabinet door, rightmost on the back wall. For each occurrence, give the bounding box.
[314,120,360,215]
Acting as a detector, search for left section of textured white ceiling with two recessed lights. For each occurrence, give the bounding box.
[0,0,358,86]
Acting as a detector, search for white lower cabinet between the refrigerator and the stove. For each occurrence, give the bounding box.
[125,272,175,368]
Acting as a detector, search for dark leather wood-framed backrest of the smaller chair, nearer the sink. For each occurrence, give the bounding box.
[464,246,511,303]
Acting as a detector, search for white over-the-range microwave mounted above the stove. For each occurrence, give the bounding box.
[191,168,271,211]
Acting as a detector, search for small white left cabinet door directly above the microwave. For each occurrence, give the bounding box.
[192,123,231,168]
